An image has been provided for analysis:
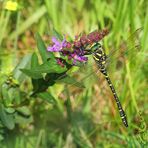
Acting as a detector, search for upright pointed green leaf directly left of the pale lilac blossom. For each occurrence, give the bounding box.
[35,33,54,62]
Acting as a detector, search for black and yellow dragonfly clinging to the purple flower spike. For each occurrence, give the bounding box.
[56,28,142,127]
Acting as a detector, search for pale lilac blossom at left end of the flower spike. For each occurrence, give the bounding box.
[47,37,67,52]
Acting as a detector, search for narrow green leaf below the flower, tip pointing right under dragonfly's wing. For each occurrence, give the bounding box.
[56,75,85,88]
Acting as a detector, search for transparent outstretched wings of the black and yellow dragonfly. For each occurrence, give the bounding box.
[54,28,142,96]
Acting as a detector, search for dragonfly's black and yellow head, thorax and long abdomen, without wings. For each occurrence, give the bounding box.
[91,43,128,127]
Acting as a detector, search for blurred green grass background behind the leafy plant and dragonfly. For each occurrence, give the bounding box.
[0,0,148,148]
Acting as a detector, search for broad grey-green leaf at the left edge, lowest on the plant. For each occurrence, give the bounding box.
[0,105,15,129]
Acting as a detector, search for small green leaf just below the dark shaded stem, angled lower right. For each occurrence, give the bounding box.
[38,92,56,104]
